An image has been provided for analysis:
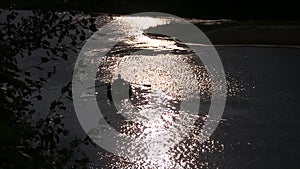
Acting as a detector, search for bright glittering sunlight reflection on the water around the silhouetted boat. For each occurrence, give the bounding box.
[88,17,239,169]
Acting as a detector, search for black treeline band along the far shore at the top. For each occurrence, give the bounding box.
[0,0,298,20]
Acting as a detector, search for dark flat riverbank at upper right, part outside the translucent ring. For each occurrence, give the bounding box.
[197,21,300,47]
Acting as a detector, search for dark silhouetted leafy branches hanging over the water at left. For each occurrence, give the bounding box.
[0,11,96,169]
